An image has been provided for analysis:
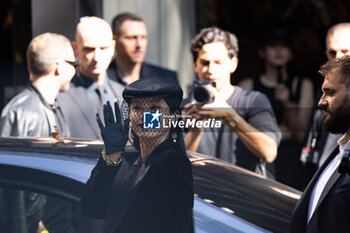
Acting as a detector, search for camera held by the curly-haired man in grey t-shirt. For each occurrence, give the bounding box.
[190,80,215,106]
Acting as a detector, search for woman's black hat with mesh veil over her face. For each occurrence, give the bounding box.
[121,77,185,153]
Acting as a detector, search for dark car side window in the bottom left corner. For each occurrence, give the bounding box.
[0,188,102,233]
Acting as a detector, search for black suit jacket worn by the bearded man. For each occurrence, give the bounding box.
[290,149,350,233]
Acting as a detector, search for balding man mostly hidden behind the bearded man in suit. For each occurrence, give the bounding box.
[300,23,350,184]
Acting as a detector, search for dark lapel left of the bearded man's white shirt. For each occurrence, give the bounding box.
[291,147,339,232]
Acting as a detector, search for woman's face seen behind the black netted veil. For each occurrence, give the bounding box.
[130,97,170,140]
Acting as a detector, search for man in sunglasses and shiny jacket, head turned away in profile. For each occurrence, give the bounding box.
[0,33,75,137]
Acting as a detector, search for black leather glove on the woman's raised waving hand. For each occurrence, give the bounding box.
[96,101,130,155]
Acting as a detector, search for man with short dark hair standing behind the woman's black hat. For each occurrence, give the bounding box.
[108,13,178,86]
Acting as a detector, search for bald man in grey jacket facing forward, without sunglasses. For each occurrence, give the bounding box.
[58,17,124,139]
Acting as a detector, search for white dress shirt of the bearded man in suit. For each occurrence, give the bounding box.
[307,135,350,223]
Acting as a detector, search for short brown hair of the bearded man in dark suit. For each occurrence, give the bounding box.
[318,55,350,87]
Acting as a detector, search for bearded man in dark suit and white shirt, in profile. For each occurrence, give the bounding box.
[290,56,350,233]
